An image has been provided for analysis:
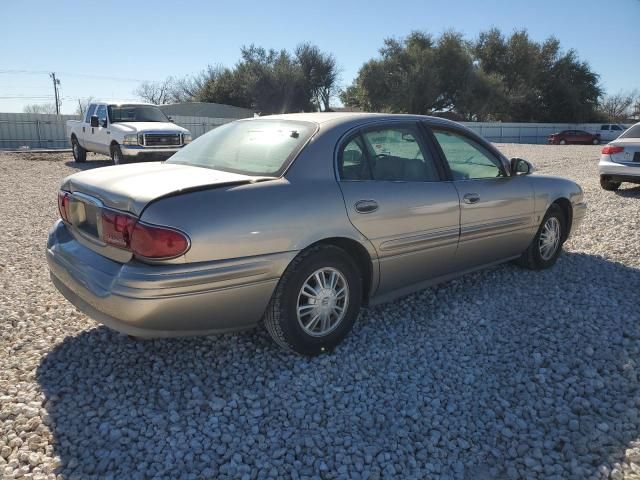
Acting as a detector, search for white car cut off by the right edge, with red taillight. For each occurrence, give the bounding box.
[598,123,640,190]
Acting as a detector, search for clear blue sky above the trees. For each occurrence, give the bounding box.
[0,0,640,113]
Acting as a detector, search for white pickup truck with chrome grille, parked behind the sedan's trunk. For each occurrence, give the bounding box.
[67,102,191,165]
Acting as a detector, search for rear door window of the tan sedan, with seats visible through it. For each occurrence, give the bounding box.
[350,126,440,182]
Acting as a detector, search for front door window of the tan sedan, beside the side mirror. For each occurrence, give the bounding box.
[433,129,506,180]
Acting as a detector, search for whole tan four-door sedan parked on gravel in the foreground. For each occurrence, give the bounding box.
[47,113,586,354]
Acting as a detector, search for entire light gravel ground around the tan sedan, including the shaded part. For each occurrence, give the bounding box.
[0,145,640,480]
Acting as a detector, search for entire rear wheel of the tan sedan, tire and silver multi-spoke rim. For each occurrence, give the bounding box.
[264,245,362,355]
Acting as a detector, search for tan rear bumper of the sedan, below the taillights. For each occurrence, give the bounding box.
[47,221,295,337]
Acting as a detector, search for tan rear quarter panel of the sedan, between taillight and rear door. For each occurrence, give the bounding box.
[141,178,366,262]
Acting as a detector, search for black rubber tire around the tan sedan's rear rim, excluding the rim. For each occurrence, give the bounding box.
[264,245,362,355]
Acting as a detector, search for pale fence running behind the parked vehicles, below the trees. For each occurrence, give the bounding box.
[0,113,616,150]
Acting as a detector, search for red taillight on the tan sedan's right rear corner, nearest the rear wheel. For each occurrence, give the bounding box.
[102,210,189,258]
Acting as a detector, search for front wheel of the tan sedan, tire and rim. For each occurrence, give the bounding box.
[518,203,568,270]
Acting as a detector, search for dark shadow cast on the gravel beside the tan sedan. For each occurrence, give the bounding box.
[37,253,640,479]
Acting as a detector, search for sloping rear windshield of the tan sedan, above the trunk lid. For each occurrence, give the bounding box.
[167,119,315,176]
